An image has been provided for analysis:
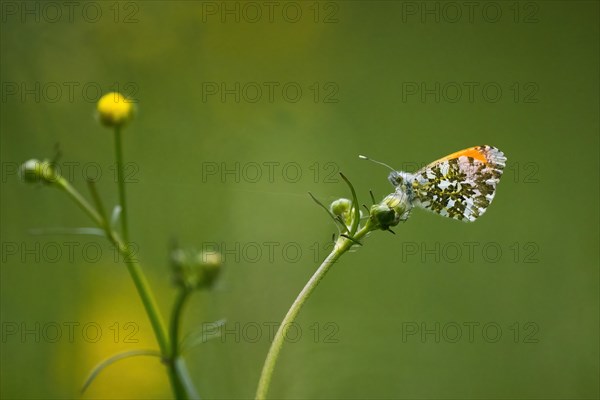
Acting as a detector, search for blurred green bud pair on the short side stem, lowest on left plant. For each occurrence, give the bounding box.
[170,249,223,290]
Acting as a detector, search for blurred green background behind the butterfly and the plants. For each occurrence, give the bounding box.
[0,1,600,399]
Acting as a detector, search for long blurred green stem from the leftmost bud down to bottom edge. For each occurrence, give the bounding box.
[56,177,189,399]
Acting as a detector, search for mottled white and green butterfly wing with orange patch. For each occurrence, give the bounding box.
[412,145,506,222]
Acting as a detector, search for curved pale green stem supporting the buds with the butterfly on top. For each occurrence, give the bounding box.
[256,223,372,400]
